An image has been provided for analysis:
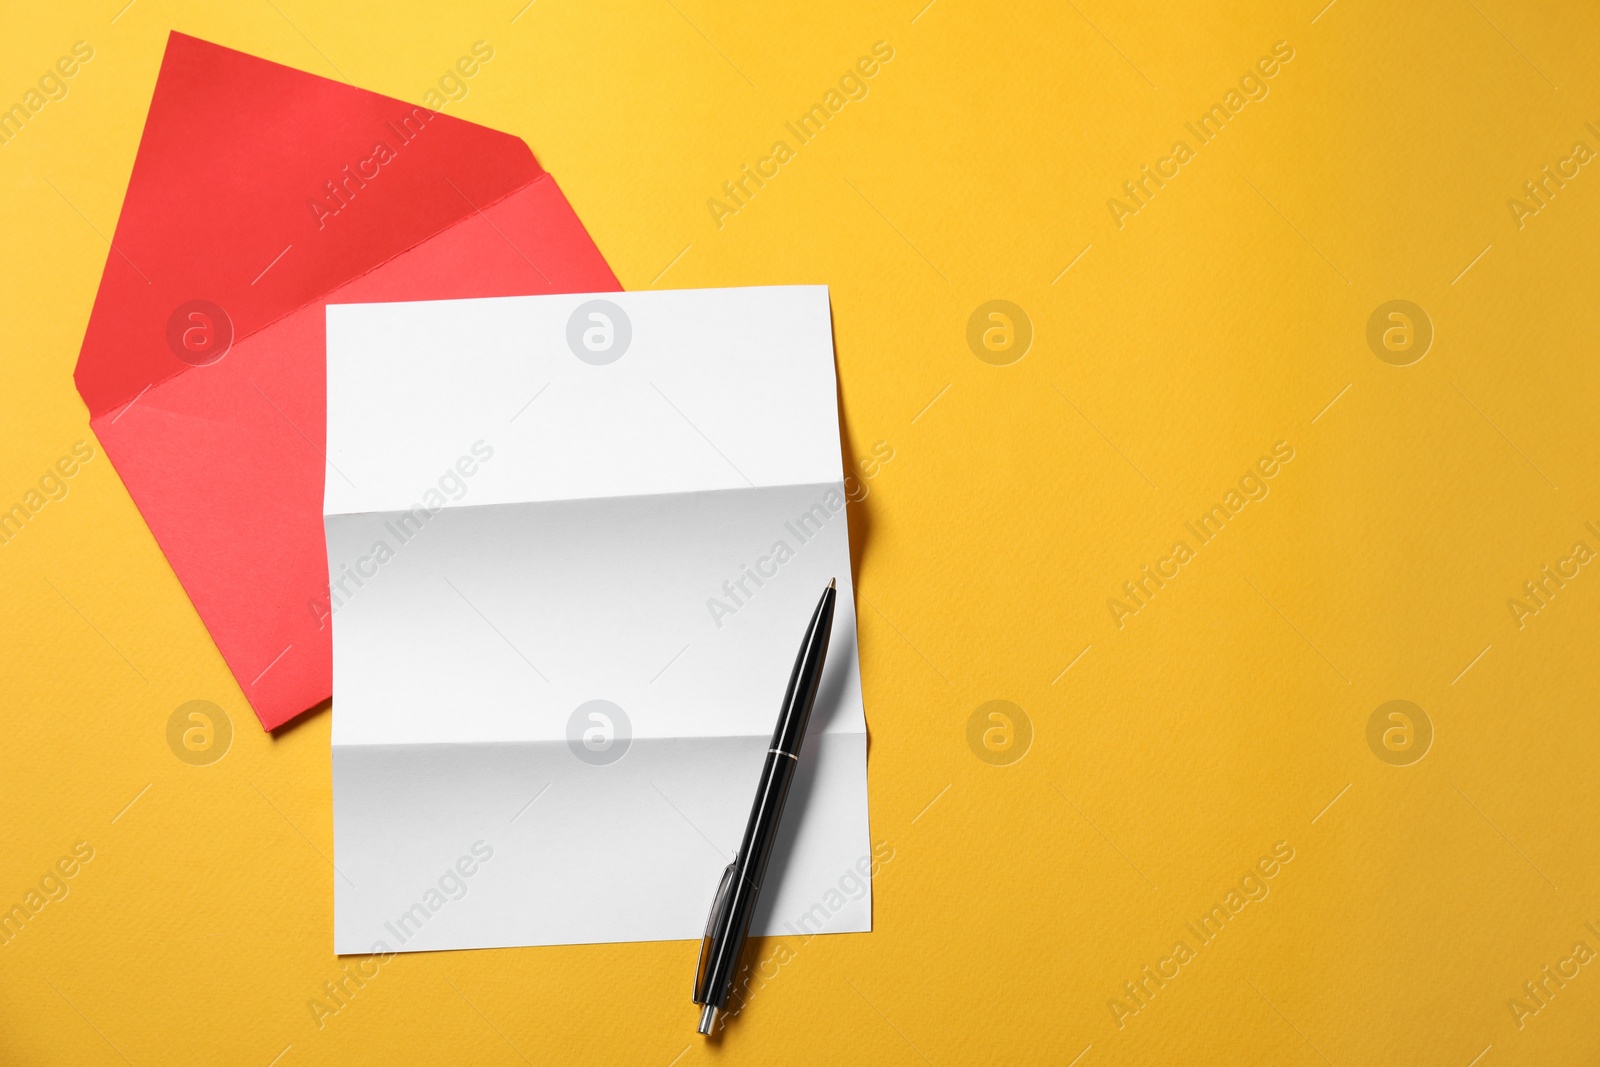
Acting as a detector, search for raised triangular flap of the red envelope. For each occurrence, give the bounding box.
[75,32,544,416]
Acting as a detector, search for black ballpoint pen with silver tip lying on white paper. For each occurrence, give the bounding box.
[694,579,838,1033]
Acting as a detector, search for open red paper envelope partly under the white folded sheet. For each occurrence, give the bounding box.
[75,34,621,729]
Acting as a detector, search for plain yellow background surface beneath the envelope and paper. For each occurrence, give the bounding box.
[0,0,1600,1067]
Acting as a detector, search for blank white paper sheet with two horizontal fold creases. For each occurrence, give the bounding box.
[325,286,874,953]
